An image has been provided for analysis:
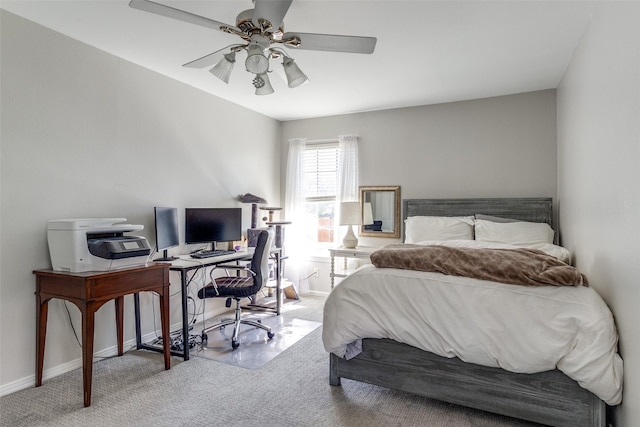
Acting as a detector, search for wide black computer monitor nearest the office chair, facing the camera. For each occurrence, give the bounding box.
[185,208,242,250]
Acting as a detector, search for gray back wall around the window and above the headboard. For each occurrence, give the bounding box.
[281,90,556,292]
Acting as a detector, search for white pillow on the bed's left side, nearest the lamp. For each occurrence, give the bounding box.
[404,216,473,243]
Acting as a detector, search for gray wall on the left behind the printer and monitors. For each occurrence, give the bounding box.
[0,10,281,393]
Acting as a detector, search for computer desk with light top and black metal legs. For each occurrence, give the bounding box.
[142,248,282,360]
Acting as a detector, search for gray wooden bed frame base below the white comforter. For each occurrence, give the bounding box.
[329,338,606,427]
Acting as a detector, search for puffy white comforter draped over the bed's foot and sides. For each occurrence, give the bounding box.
[322,265,622,405]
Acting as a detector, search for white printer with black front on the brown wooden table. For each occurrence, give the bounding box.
[47,218,151,273]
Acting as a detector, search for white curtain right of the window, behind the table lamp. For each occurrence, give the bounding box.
[333,135,360,246]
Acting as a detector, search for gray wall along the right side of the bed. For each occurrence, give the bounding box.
[558,2,640,427]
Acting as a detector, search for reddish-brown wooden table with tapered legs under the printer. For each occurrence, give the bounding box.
[33,264,171,407]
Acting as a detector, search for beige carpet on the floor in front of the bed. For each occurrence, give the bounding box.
[0,296,534,427]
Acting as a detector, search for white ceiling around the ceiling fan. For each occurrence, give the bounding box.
[0,0,595,120]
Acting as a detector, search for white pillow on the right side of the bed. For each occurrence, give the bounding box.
[475,219,553,246]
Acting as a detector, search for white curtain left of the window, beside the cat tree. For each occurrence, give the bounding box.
[284,138,309,292]
